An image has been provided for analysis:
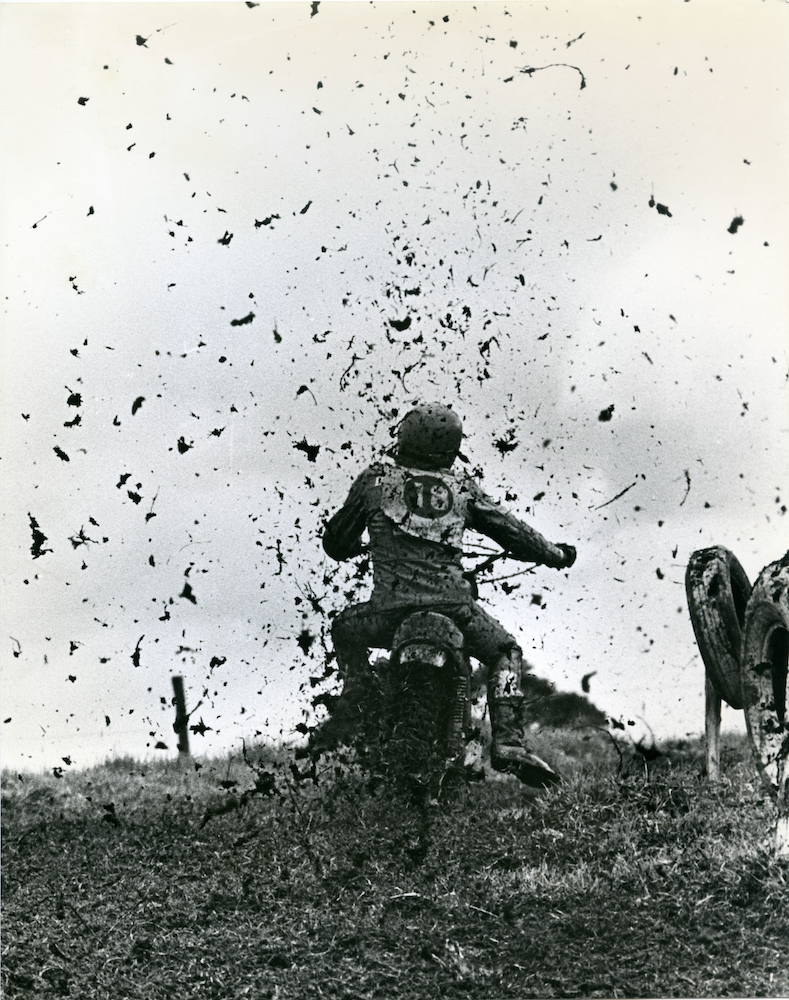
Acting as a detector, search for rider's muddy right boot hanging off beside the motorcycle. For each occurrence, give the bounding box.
[488,646,561,788]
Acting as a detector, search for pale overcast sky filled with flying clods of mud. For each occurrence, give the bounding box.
[0,0,789,767]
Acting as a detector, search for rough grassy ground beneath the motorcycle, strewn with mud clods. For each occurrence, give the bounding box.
[2,731,789,1000]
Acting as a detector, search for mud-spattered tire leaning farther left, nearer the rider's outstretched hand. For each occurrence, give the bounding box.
[685,545,751,708]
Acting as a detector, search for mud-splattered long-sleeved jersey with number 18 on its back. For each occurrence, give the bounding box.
[323,462,564,605]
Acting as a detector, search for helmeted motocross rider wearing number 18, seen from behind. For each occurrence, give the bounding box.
[323,403,575,786]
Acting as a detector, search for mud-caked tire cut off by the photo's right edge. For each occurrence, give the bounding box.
[742,552,789,798]
